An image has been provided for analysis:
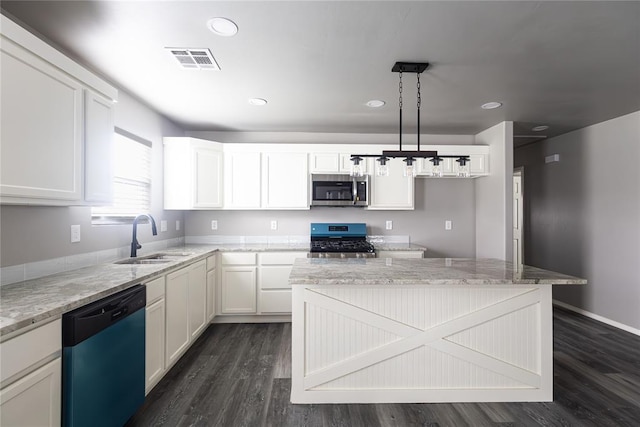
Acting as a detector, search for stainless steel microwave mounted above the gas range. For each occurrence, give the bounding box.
[311,174,369,207]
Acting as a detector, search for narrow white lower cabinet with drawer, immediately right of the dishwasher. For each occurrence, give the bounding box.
[145,276,166,394]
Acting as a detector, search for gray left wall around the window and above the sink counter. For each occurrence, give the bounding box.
[0,92,184,267]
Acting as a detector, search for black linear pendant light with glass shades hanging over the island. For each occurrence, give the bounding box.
[351,62,469,177]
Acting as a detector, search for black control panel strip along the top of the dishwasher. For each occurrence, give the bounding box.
[62,285,147,347]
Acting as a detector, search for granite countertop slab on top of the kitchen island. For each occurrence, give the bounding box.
[289,258,587,285]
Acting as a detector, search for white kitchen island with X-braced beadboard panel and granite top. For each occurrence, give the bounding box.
[289,258,586,403]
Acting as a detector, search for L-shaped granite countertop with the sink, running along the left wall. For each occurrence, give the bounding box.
[0,243,309,336]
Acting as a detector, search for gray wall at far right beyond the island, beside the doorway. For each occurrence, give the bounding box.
[515,111,640,329]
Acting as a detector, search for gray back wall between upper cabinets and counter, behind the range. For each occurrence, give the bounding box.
[185,178,476,257]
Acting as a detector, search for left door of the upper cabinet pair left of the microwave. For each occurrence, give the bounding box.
[224,152,262,209]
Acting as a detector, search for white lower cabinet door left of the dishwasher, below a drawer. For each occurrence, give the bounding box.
[0,357,62,427]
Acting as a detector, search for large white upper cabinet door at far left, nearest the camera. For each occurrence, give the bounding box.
[0,37,83,204]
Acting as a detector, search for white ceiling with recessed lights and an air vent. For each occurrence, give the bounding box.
[2,0,640,144]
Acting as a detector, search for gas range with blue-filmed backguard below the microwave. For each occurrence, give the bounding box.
[309,222,376,258]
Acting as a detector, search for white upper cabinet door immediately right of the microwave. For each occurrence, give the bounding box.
[368,158,414,210]
